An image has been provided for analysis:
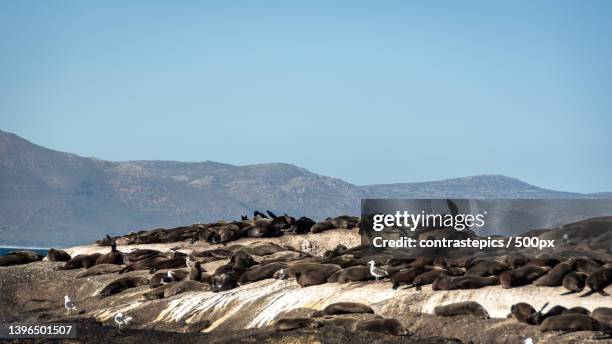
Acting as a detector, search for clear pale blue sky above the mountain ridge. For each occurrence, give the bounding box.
[0,1,612,192]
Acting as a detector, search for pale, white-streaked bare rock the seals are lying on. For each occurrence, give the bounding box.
[0,230,612,344]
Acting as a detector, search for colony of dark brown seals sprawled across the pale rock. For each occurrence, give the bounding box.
[1,212,612,335]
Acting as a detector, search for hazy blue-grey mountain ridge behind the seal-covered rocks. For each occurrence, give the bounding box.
[0,131,611,246]
